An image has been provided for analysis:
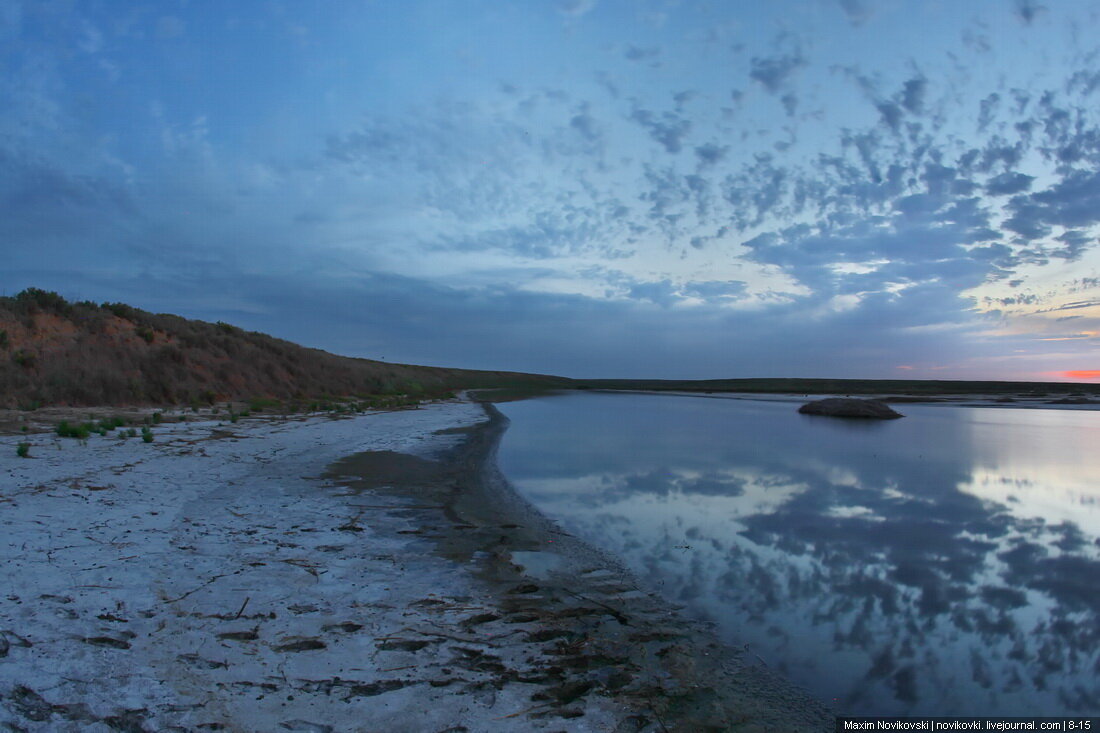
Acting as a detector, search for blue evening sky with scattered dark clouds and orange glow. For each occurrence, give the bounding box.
[0,0,1100,381]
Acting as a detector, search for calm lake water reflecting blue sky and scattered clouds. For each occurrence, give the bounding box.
[499,394,1100,715]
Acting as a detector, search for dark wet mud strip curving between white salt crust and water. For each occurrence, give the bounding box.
[328,403,834,731]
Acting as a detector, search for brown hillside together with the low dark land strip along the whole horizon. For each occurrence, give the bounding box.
[0,287,1100,411]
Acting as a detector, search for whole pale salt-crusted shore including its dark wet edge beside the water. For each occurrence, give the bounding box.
[0,402,832,733]
